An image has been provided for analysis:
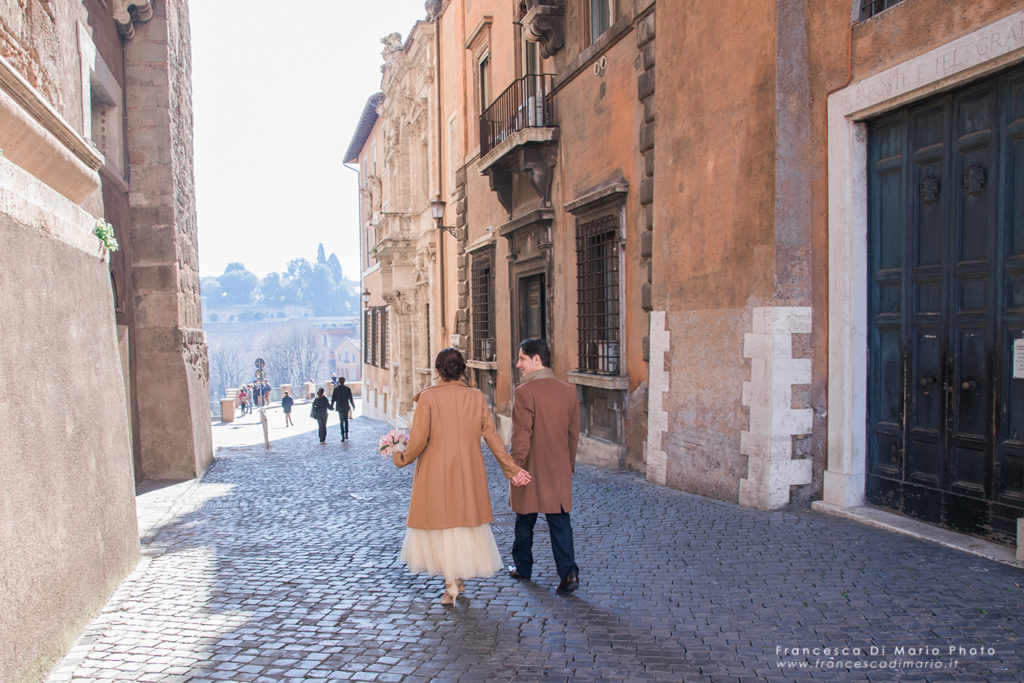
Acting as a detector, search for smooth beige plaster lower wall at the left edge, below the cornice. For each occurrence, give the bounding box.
[0,165,138,681]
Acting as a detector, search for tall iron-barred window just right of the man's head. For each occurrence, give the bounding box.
[577,215,621,375]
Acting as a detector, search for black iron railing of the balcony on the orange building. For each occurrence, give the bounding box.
[480,74,555,157]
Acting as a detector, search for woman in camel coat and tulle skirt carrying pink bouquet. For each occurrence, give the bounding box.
[392,348,529,605]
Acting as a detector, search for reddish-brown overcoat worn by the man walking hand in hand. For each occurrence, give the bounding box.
[509,368,580,514]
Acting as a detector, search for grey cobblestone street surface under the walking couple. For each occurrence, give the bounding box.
[49,405,1024,683]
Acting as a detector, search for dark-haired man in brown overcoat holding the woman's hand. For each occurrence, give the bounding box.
[509,339,580,593]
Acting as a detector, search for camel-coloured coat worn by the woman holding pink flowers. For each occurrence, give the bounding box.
[392,381,521,529]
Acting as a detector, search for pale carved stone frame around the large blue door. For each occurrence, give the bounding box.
[821,10,1024,508]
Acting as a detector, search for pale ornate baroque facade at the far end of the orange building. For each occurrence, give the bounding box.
[345,22,443,425]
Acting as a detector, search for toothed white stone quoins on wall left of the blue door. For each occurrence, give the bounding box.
[741,306,813,510]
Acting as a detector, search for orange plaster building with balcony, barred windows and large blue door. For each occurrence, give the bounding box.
[352,0,1024,557]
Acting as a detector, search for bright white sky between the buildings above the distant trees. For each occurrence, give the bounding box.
[188,0,426,280]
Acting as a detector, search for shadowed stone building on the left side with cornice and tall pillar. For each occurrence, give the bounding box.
[0,0,213,681]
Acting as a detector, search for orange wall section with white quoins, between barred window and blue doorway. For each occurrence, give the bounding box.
[648,0,850,507]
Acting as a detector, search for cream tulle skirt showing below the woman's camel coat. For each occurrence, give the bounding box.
[401,524,502,581]
